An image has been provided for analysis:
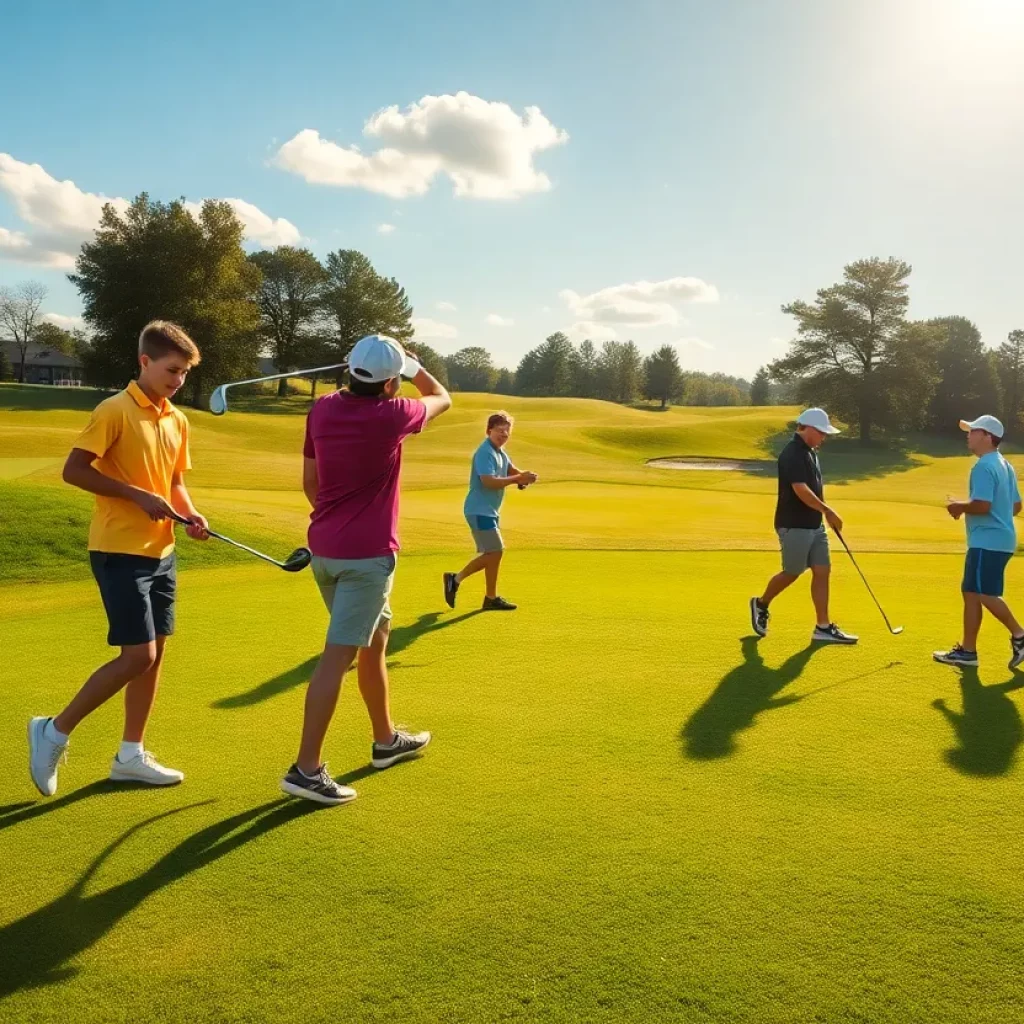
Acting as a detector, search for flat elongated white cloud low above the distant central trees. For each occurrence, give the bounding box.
[558,278,719,328]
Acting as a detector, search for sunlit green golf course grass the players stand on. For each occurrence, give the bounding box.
[0,387,1024,1024]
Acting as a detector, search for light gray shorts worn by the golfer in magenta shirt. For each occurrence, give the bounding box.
[312,554,397,647]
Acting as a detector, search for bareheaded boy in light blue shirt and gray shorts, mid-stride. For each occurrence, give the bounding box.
[444,412,537,611]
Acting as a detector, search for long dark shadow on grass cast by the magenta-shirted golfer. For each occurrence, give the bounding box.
[0,800,315,999]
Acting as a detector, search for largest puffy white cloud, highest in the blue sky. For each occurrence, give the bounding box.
[273,92,568,199]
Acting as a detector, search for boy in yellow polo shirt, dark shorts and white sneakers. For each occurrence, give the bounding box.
[29,321,209,797]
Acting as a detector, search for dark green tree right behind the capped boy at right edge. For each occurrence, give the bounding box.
[928,316,1000,434]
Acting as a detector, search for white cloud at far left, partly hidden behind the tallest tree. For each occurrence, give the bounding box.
[0,153,300,268]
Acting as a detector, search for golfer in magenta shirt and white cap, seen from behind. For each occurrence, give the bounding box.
[281,334,452,804]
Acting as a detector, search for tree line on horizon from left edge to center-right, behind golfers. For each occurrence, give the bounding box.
[0,194,751,406]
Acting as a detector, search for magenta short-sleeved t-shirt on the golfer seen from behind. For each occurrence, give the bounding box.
[303,391,427,558]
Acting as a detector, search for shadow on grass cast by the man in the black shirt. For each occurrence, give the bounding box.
[680,637,822,761]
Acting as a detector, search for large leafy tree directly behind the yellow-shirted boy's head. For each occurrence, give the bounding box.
[69,194,260,404]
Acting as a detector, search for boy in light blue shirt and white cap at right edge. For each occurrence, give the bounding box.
[933,416,1024,669]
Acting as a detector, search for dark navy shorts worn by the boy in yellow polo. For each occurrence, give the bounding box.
[89,551,177,647]
